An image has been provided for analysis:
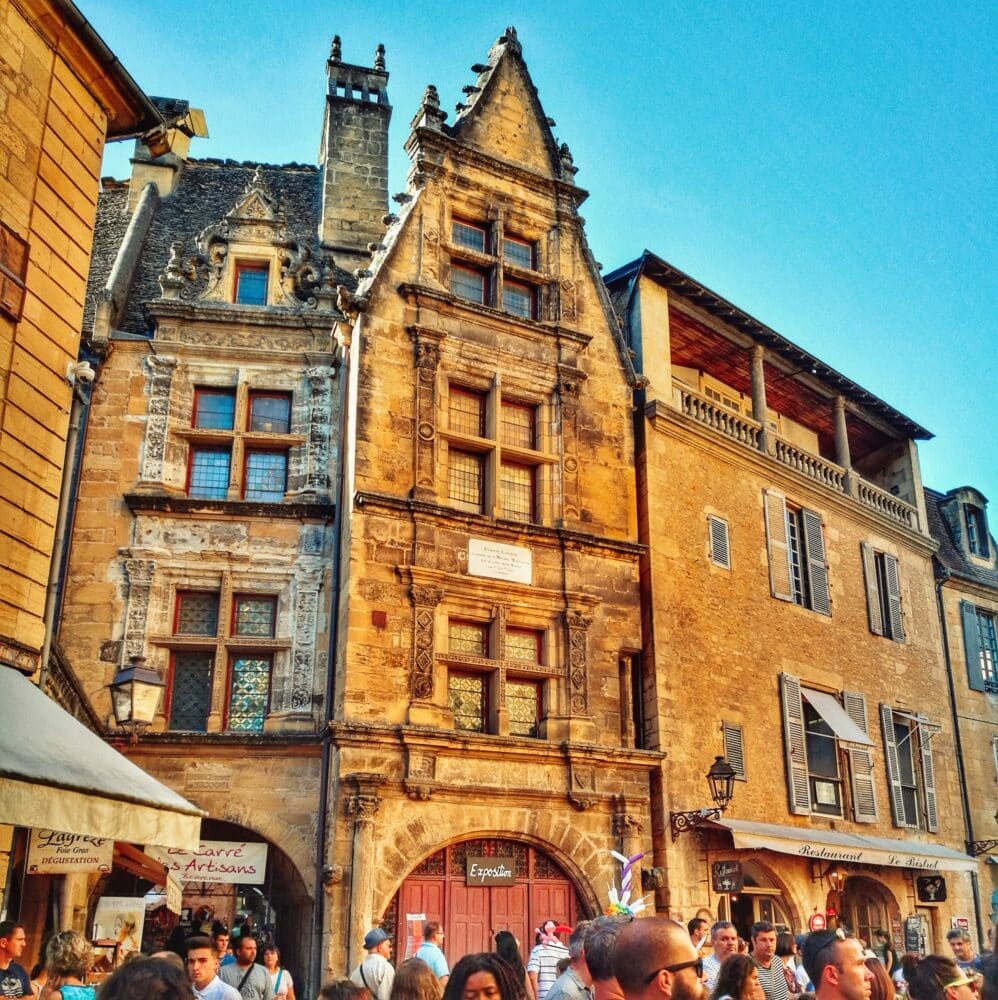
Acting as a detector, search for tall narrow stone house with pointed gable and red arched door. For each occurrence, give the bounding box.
[325,29,660,968]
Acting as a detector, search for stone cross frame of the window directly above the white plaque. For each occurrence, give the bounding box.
[435,374,560,525]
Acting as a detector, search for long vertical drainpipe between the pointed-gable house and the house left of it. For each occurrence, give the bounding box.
[309,318,350,996]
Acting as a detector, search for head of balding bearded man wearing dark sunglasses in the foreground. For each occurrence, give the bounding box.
[613,917,707,1000]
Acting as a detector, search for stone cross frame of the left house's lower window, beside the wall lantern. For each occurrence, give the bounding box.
[148,568,294,733]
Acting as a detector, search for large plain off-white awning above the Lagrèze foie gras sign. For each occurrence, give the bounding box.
[0,667,205,850]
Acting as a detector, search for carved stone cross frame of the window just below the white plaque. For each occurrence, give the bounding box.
[435,598,564,739]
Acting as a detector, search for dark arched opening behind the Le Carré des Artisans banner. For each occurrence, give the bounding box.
[171,819,312,984]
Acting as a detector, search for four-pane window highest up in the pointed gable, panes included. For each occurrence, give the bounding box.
[450,219,538,319]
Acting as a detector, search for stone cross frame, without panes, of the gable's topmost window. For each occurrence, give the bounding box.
[442,205,550,322]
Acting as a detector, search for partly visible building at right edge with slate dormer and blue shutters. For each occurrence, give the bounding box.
[925,486,998,925]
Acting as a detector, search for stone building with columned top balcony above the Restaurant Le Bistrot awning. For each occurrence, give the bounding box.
[607,253,976,951]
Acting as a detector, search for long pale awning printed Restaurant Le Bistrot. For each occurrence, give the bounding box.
[716,818,977,872]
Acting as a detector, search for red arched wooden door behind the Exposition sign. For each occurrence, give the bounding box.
[384,837,592,965]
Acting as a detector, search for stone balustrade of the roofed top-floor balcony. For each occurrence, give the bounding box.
[673,382,918,530]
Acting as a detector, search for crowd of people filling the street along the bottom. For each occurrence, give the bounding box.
[0,914,998,1000]
